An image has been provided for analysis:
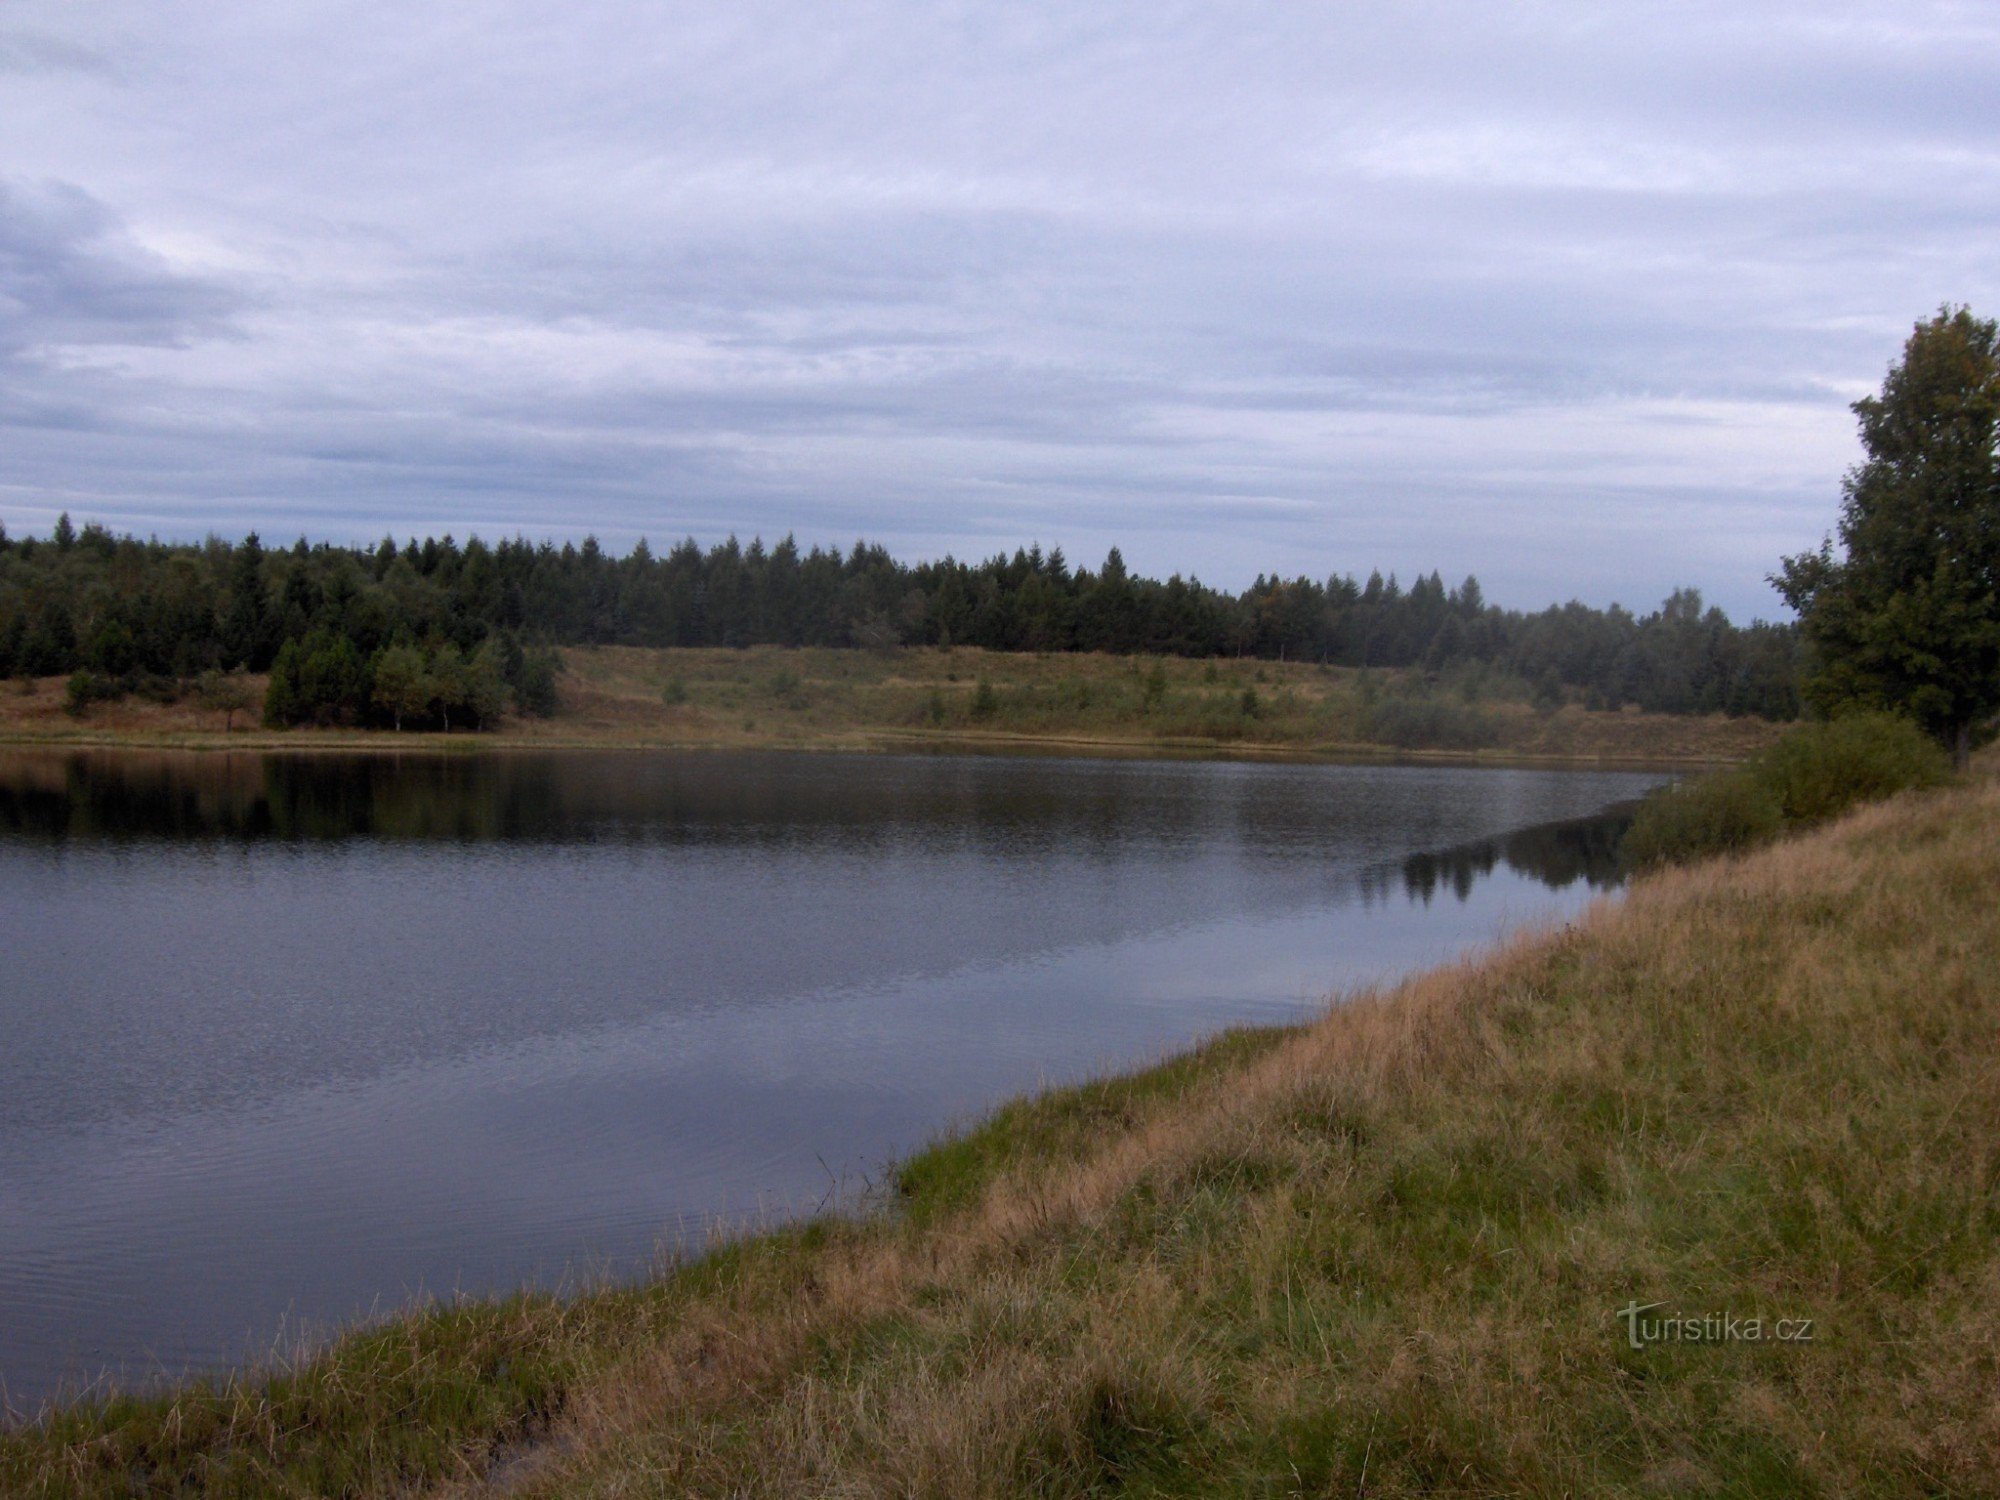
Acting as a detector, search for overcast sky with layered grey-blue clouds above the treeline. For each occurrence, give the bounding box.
[0,0,2000,620]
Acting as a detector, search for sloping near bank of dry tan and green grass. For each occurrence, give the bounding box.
[0,778,2000,1496]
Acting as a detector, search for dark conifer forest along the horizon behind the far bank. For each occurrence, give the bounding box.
[0,516,1798,728]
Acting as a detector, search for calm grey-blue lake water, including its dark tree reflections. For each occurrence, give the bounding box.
[0,752,1660,1410]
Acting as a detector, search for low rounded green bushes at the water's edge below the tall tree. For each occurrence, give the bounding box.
[1622,714,1950,870]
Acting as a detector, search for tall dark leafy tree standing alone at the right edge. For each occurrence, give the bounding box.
[1772,308,2000,766]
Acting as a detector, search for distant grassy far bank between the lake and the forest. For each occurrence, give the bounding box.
[0,646,1778,762]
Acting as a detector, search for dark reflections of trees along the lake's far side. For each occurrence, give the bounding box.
[0,750,1656,892]
